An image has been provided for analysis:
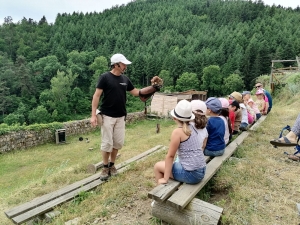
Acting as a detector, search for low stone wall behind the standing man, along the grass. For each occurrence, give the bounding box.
[0,112,145,153]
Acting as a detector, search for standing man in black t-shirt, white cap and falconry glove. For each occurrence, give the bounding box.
[91,54,161,180]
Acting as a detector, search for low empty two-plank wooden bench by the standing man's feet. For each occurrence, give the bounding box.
[4,145,165,224]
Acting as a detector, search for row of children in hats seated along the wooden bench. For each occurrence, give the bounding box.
[154,81,272,184]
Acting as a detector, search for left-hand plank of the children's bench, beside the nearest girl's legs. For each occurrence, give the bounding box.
[148,156,210,202]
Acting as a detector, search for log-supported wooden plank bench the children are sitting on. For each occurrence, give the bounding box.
[148,132,249,225]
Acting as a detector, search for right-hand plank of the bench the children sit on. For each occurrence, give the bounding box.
[167,132,249,210]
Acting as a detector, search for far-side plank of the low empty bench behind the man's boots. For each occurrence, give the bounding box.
[4,145,163,218]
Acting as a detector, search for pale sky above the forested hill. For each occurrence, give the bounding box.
[0,0,300,24]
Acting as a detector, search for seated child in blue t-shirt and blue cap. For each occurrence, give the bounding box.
[204,97,225,156]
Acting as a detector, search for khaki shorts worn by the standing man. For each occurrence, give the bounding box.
[101,115,125,152]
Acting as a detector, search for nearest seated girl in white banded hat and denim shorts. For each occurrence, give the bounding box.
[154,100,206,184]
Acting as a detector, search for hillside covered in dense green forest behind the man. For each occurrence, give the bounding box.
[0,0,300,124]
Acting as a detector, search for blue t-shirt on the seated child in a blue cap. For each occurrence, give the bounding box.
[205,116,225,151]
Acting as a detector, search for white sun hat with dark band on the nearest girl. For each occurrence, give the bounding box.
[170,100,195,121]
